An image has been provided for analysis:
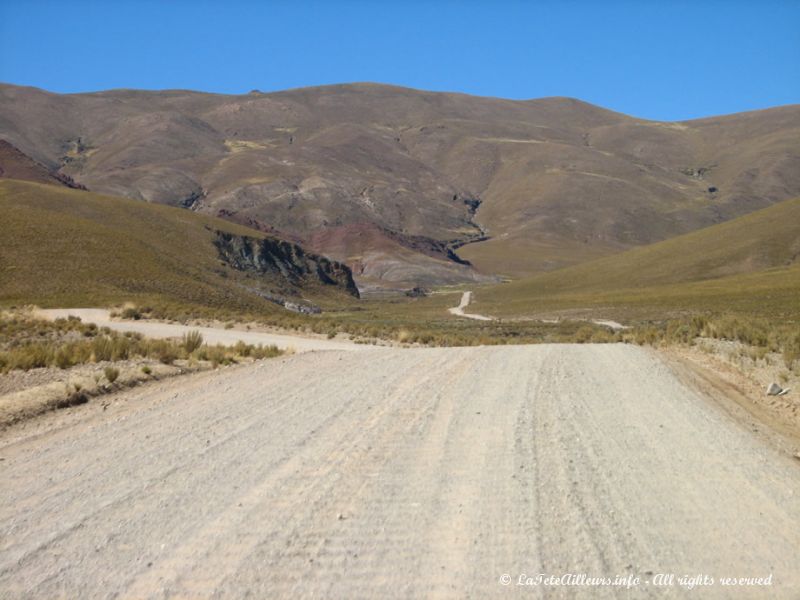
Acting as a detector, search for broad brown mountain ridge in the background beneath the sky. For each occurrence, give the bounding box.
[0,84,800,282]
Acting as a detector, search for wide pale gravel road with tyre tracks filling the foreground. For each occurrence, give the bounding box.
[0,345,800,599]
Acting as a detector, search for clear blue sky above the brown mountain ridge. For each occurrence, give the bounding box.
[0,0,800,120]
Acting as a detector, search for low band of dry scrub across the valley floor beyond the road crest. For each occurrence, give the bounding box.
[97,290,800,369]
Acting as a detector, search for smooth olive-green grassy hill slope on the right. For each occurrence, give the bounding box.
[476,199,800,315]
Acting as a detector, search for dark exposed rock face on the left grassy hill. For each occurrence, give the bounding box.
[214,231,359,298]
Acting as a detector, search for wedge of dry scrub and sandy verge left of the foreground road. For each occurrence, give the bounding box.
[0,311,284,428]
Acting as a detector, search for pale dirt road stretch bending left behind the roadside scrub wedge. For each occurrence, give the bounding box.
[37,308,364,352]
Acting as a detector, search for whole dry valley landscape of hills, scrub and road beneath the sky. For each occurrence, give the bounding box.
[0,83,800,598]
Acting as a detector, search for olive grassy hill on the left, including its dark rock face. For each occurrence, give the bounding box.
[0,180,357,313]
